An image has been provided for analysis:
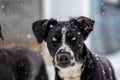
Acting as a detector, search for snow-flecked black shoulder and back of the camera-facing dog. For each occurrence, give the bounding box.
[81,45,116,80]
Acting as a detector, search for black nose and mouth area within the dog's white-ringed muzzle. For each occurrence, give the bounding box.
[57,51,71,67]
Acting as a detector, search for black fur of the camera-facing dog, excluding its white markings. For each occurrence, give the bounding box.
[32,16,116,80]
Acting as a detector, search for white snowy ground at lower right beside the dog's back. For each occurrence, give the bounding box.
[107,52,120,80]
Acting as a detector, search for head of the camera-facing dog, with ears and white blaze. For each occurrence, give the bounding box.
[32,17,94,68]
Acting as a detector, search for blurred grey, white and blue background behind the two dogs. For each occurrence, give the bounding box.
[0,0,120,80]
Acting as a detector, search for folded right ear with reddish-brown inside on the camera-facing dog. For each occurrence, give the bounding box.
[77,16,95,40]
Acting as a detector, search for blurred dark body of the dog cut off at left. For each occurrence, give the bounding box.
[0,46,48,80]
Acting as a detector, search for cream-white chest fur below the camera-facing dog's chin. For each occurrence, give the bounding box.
[58,64,82,80]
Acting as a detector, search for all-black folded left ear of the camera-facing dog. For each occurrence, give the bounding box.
[32,19,57,43]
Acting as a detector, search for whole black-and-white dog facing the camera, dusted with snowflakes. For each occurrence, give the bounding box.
[32,16,116,80]
